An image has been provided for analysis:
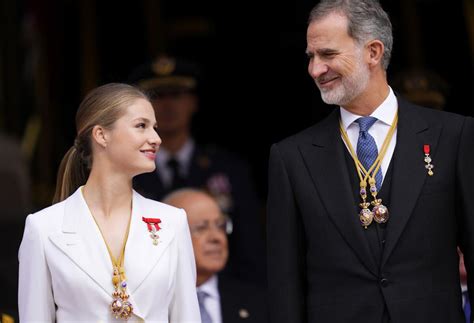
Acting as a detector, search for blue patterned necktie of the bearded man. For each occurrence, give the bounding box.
[355,117,383,191]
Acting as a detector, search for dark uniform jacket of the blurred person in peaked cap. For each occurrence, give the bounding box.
[134,145,265,282]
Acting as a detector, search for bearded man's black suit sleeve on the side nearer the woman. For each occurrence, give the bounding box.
[267,144,306,323]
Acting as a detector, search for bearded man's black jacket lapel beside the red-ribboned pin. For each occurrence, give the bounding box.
[382,98,441,266]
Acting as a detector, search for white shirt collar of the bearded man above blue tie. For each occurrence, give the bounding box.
[340,87,398,130]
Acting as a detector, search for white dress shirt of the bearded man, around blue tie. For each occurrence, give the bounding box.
[340,87,398,182]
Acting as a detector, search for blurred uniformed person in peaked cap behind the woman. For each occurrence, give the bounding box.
[129,55,265,283]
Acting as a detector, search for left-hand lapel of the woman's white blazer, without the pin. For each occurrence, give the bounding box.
[49,188,113,295]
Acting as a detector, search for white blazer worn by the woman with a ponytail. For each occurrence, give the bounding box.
[18,188,201,323]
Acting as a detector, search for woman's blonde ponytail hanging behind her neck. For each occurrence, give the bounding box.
[53,145,89,204]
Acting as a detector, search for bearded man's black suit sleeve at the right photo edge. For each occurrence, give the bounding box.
[456,118,474,322]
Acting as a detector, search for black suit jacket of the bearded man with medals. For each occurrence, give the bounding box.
[267,98,474,323]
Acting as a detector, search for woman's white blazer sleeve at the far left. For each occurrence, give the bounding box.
[18,215,55,323]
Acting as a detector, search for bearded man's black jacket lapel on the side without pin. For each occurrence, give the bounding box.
[299,109,378,275]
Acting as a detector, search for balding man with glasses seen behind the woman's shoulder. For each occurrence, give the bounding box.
[163,188,267,323]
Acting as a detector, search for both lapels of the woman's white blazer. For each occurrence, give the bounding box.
[49,189,175,317]
